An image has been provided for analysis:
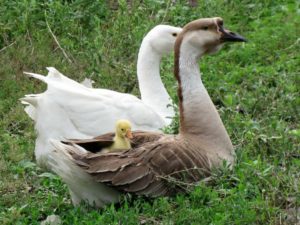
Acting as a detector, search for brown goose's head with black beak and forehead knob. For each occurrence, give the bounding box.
[175,17,246,57]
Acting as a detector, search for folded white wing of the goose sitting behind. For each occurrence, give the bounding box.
[22,68,165,138]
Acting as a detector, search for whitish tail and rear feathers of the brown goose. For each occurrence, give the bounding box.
[49,140,120,207]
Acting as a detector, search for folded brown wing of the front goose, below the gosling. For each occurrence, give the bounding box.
[65,132,210,197]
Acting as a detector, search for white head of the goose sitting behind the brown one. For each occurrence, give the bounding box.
[145,25,182,55]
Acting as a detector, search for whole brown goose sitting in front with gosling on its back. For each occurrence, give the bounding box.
[51,18,245,206]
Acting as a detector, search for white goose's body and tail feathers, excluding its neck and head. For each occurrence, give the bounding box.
[21,68,166,167]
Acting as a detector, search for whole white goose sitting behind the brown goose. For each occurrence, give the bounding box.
[21,25,181,168]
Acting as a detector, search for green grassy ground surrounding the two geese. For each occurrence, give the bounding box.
[0,0,300,224]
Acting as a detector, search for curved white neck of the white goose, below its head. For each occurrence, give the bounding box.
[137,40,175,125]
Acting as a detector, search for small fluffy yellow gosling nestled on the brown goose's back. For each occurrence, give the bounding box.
[101,119,132,153]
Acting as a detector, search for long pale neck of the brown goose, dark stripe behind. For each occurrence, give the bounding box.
[175,40,232,149]
